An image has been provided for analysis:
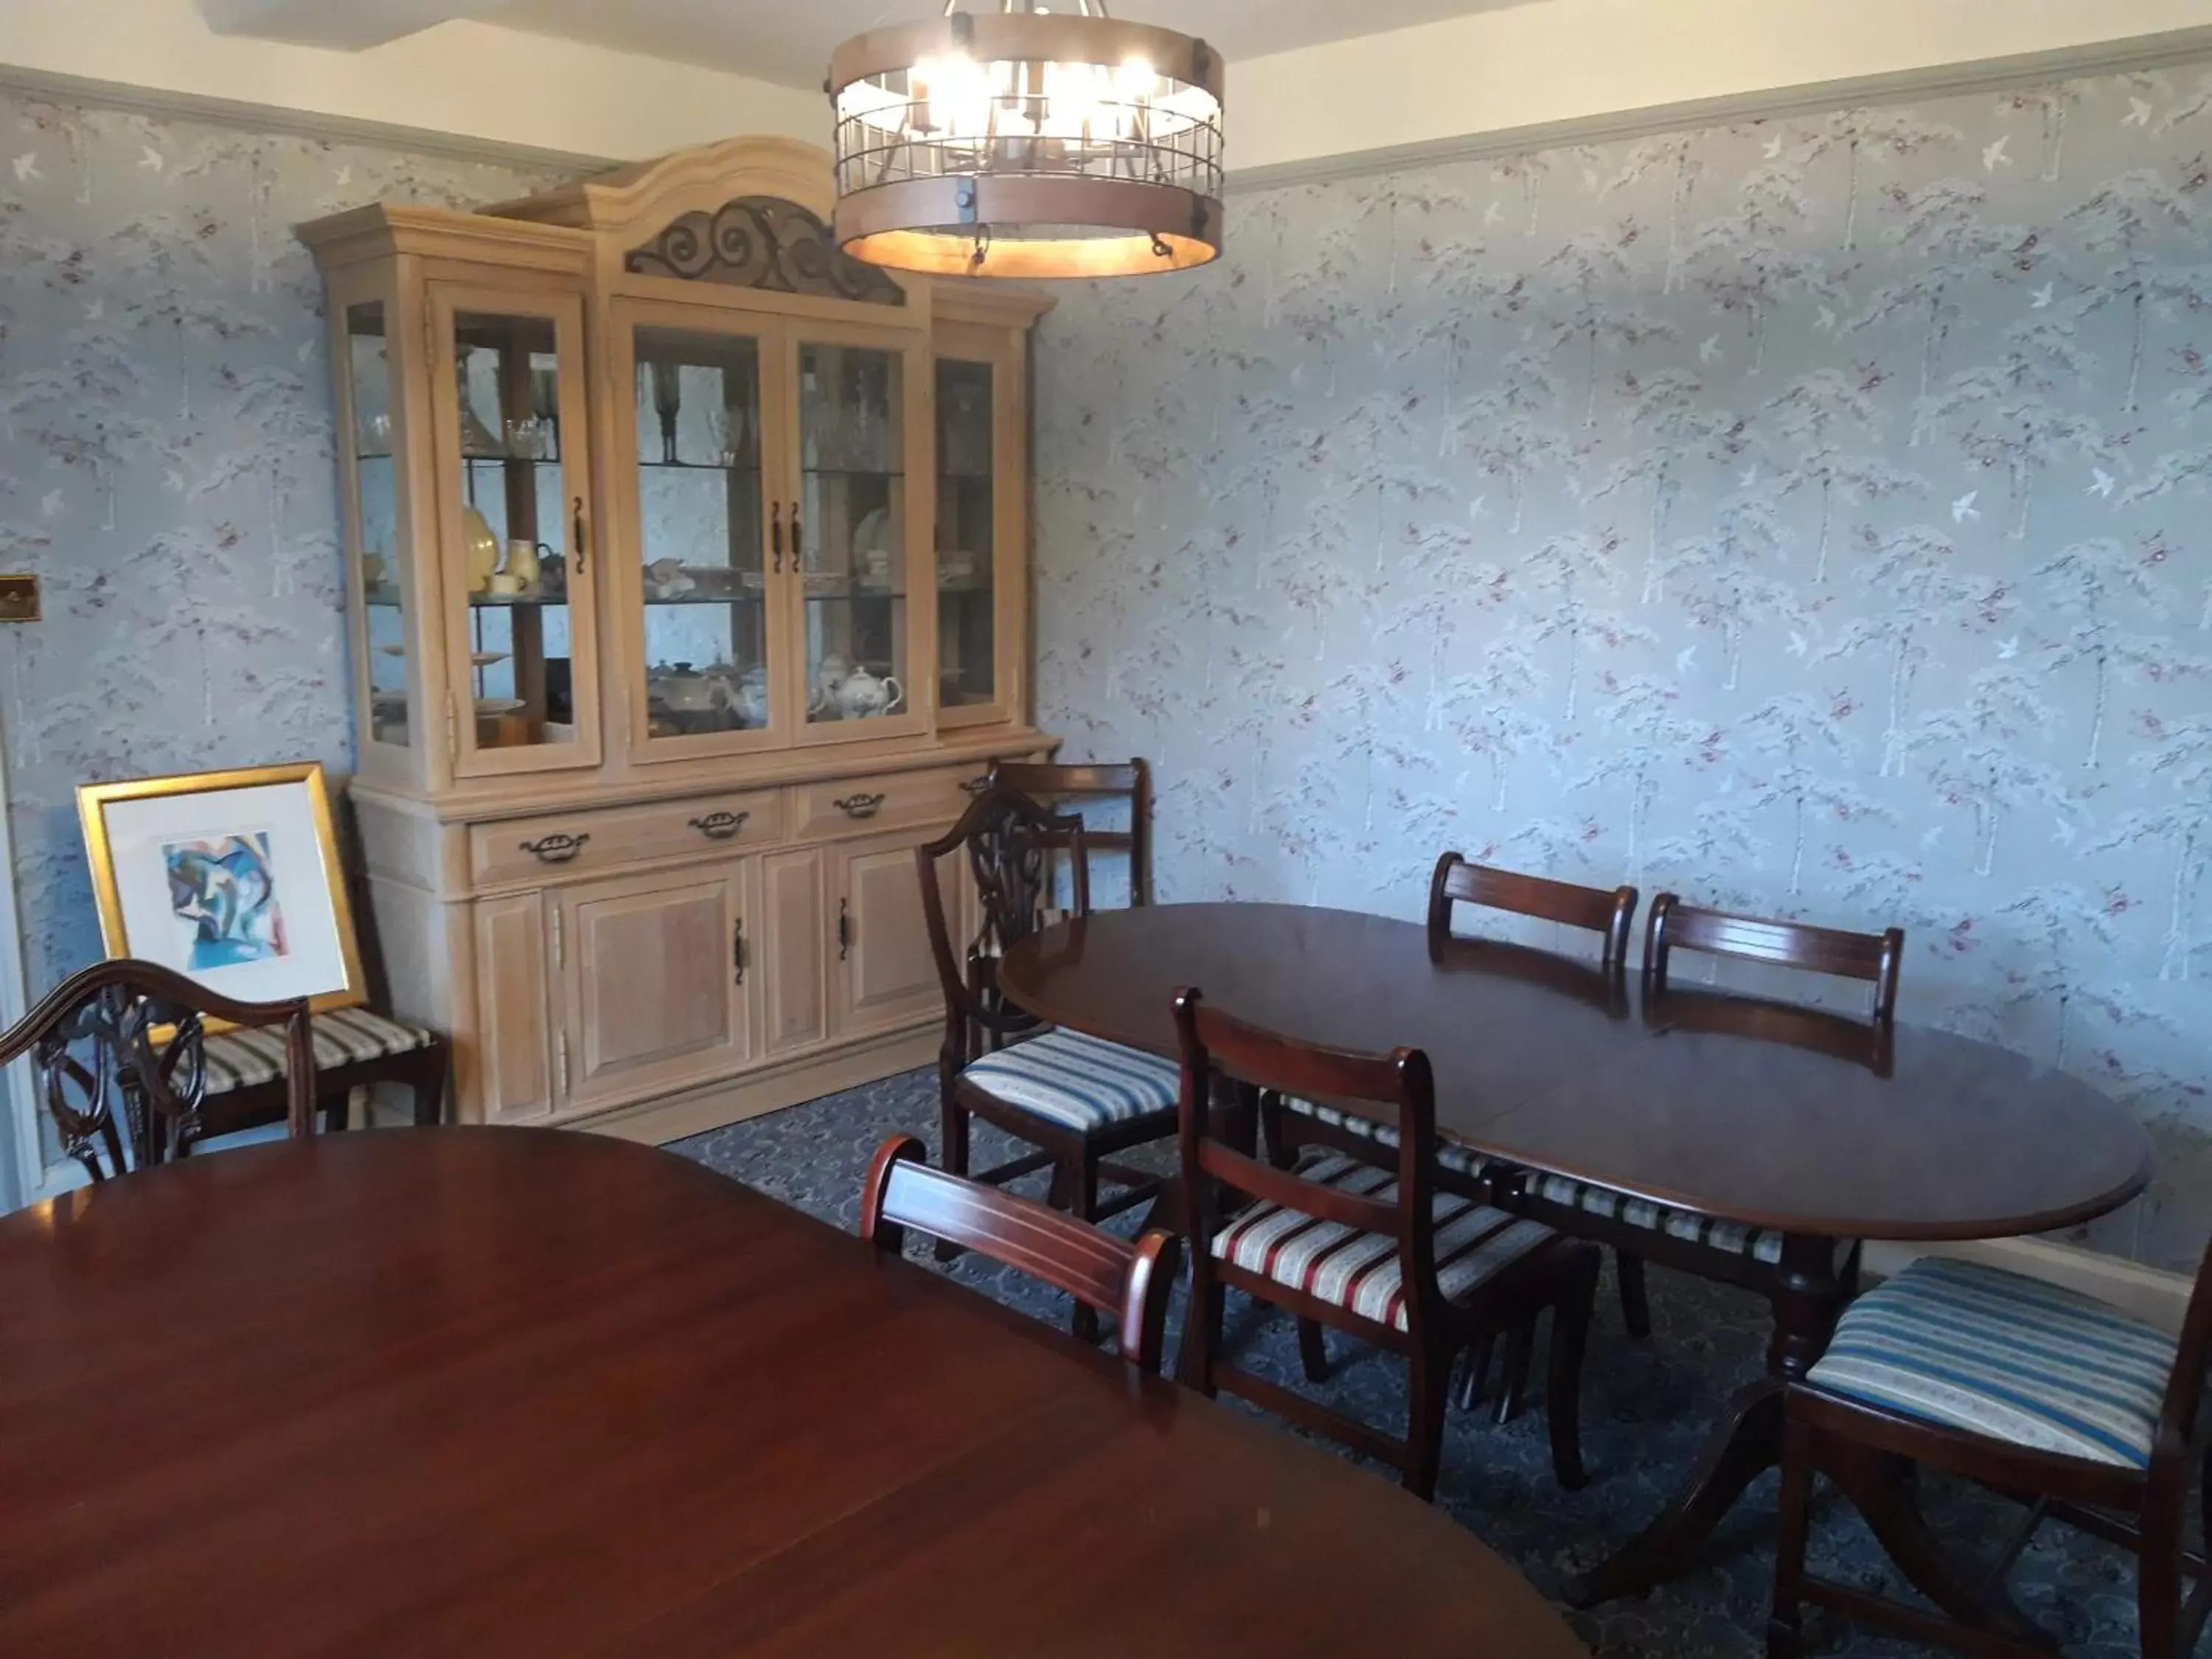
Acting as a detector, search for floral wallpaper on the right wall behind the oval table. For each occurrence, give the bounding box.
[1037,71,2212,1267]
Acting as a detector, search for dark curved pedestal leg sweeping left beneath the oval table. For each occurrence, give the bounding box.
[1566,1234,1843,1608]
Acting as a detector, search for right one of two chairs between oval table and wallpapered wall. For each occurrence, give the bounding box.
[1489,894,1905,1334]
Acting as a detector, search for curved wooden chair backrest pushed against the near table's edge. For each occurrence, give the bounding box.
[860,1135,1179,1376]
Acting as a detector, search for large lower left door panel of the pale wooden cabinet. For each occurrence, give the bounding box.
[560,865,752,1106]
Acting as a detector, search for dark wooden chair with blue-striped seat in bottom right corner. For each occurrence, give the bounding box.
[1767,1250,2212,1659]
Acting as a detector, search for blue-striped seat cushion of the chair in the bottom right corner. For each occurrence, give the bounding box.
[1807,1256,2174,1469]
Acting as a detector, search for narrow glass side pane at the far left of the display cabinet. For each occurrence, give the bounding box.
[338,299,414,748]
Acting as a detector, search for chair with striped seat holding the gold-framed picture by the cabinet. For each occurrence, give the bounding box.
[201,1009,449,1139]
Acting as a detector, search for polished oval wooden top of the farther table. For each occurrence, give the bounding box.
[1000,905,2152,1239]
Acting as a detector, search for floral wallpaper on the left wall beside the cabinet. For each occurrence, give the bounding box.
[0,95,555,993]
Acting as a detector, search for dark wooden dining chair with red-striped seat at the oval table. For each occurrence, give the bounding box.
[1175,989,1599,1498]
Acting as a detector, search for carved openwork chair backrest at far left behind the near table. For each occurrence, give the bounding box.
[0,958,314,1181]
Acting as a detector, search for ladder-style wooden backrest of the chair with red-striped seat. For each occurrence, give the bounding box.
[1175,987,1442,1340]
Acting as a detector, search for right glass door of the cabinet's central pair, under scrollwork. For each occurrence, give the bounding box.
[792,338,927,737]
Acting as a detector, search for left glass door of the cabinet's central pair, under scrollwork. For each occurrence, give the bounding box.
[624,312,785,754]
